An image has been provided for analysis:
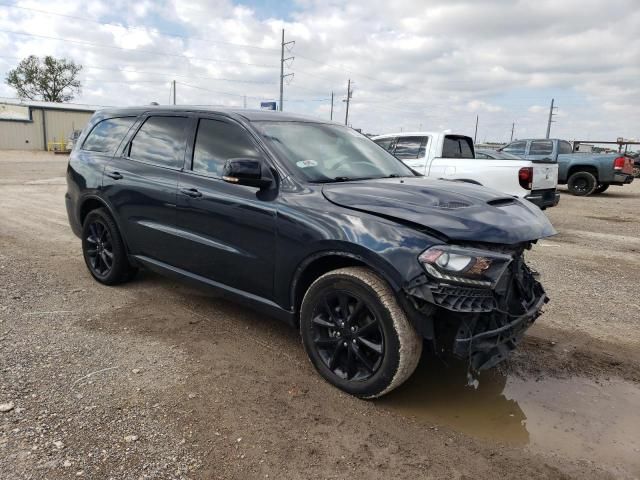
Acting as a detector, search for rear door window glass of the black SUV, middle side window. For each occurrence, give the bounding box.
[129,117,187,168]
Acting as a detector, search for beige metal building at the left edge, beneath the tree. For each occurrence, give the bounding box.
[0,98,100,150]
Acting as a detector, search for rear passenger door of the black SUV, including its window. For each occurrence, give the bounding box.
[103,114,191,264]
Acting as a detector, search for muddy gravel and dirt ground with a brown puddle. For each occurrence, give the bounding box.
[0,152,640,479]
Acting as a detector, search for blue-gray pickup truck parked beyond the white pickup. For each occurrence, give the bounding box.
[500,138,633,196]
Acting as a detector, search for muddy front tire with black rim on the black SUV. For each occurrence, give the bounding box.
[300,267,422,398]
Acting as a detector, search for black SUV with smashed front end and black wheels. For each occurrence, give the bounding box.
[66,106,555,398]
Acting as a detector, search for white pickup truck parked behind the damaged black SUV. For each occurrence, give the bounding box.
[372,132,560,209]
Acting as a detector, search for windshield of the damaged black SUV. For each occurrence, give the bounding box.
[253,122,415,183]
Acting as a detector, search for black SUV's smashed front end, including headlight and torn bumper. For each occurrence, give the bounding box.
[404,242,549,371]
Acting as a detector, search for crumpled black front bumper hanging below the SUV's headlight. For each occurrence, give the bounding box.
[405,256,549,371]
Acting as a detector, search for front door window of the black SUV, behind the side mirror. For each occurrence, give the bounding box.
[192,118,261,177]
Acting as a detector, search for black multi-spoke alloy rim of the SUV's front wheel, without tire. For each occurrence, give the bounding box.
[312,291,385,381]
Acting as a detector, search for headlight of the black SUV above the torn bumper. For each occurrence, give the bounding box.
[418,245,512,288]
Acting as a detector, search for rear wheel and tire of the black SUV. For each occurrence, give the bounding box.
[82,208,137,285]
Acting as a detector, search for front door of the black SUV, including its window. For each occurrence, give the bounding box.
[177,116,276,299]
